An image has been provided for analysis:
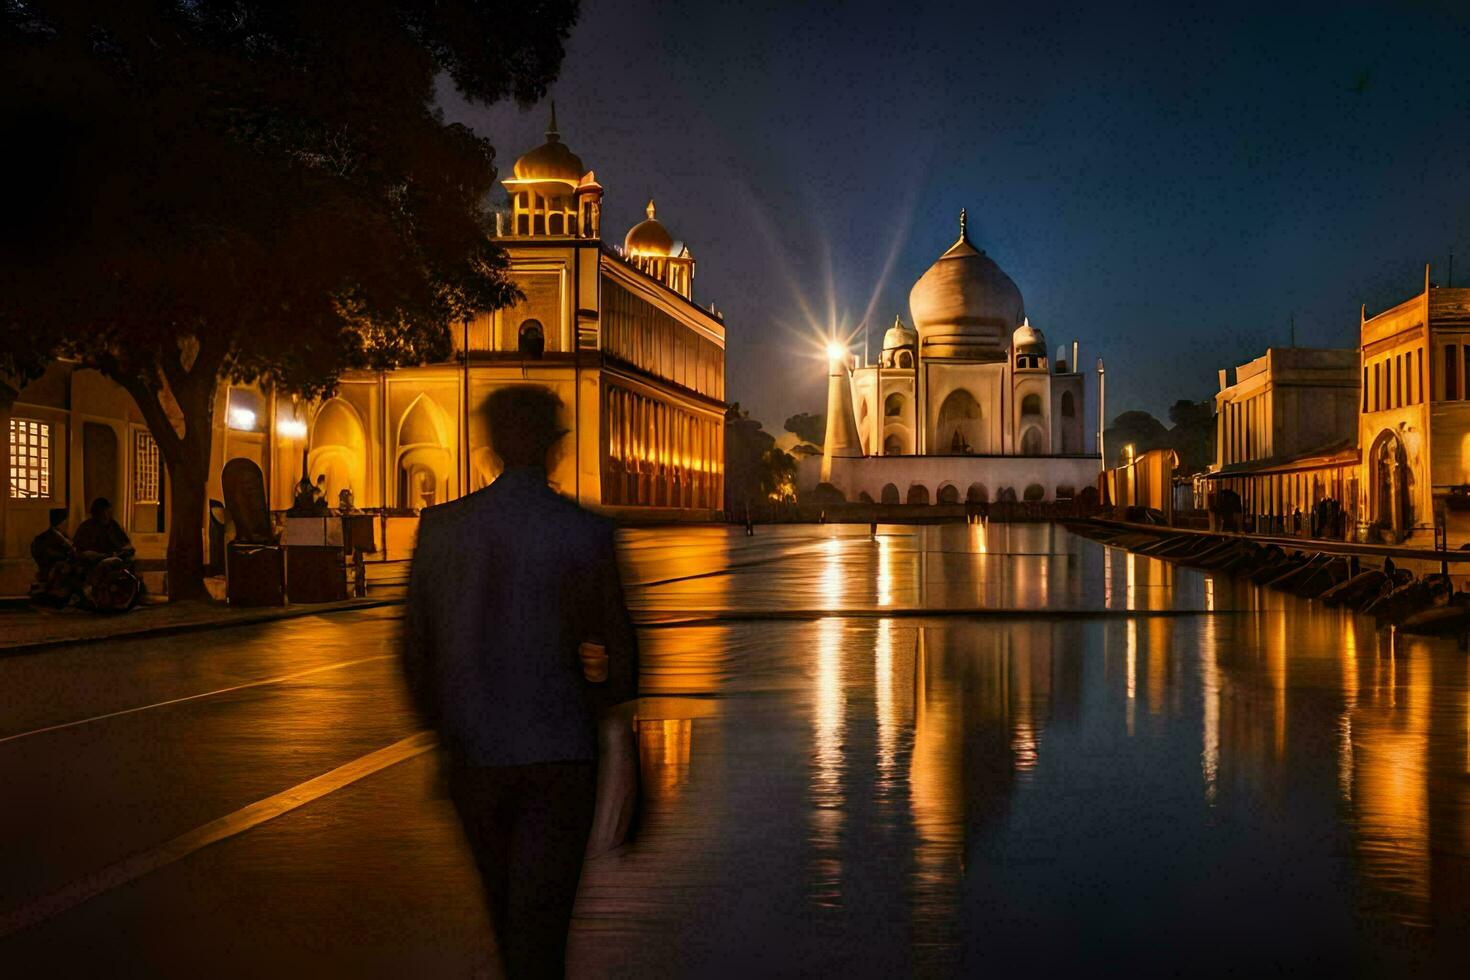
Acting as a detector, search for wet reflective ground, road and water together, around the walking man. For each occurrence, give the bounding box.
[0,525,1470,977]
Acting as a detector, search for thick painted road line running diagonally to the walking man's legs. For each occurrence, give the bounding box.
[0,732,438,937]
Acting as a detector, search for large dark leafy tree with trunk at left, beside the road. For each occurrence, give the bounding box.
[0,0,578,598]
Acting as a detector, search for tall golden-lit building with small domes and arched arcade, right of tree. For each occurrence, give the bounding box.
[272,110,725,519]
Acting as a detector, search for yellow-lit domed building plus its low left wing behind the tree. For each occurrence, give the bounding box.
[0,116,725,595]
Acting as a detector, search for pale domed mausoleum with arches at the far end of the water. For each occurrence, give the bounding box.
[803,212,1100,502]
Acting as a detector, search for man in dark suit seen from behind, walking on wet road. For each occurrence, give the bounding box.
[403,385,638,979]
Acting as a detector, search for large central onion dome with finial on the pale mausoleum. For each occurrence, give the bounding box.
[908,212,1026,361]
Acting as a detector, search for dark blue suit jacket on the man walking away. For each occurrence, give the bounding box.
[403,469,638,765]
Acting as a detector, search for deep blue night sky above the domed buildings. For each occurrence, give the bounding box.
[442,0,1470,432]
